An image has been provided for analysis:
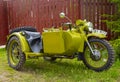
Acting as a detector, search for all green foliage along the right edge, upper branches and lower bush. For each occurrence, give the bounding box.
[105,0,120,59]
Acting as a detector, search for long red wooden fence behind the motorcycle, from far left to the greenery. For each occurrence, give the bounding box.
[0,0,115,44]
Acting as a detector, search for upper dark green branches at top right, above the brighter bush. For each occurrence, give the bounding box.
[103,0,120,38]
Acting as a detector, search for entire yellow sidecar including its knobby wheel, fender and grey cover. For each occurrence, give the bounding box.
[6,27,84,69]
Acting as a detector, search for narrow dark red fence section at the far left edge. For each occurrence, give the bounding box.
[0,0,8,45]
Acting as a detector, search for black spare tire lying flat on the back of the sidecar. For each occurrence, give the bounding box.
[10,26,37,34]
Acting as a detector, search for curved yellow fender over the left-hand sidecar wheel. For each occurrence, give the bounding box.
[6,32,31,52]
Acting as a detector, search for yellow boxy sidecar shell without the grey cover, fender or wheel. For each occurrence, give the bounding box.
[42,31,84,55]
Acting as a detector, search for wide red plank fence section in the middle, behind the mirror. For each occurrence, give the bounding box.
[7,0,79,32]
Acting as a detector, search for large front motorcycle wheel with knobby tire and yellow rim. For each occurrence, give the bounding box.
[82,38,115,72]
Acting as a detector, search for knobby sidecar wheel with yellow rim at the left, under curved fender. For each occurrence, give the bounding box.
[7,36,26,70]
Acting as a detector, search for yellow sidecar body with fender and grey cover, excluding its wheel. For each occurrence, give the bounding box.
[8,30,84,58]
